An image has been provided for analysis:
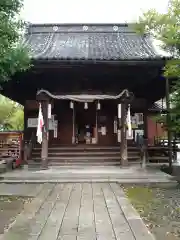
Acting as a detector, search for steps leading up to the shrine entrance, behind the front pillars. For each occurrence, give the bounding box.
[32,145,140,166]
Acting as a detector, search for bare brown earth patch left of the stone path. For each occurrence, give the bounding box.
[0,196,31,234]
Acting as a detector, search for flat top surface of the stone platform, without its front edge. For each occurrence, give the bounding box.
[0,166,172,180]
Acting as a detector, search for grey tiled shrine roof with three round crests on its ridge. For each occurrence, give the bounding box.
[24,24,169,60]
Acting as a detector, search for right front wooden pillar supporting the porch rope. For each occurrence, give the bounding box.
[120,103,128,166]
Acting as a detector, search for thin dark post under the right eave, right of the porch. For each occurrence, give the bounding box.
[166,78,173,168]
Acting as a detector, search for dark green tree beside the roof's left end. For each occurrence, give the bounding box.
[0,0,29,81]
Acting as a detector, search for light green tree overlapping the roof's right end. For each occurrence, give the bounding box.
[136,0,180,132]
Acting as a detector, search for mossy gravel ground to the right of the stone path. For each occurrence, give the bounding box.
[122,184,180,240]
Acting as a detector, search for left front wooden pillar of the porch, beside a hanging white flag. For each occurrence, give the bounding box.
[41,100,49,169]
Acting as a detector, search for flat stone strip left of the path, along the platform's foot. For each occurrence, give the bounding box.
[0,183,42,197]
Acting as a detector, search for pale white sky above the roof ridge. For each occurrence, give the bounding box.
[22,0,168,23]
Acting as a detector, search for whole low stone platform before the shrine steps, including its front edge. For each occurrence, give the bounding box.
[0,166,172,183]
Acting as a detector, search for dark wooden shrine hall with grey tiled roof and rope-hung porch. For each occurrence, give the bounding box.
[2,24,170,168]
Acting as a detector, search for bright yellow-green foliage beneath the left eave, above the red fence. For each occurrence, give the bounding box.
[0,95,24,131]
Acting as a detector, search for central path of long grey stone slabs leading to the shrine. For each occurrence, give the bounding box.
[0,183,154,240]
